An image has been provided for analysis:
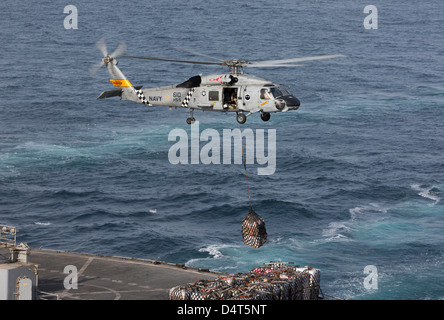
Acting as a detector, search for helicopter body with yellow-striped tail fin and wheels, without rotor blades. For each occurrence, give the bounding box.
[98,56,300,124]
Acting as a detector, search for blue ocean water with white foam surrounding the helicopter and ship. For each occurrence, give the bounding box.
[0,0,444,300]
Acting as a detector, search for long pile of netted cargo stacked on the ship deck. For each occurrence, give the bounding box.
[169,263,320,300]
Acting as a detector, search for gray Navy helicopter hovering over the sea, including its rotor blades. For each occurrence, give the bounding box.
[90,39,345,124]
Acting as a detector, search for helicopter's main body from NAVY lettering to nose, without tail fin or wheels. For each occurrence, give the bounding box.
[141,74,300,113]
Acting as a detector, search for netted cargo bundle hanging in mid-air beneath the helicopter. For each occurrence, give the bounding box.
[242,208,267,248]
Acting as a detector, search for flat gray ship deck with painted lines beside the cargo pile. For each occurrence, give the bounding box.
[29,249,222,300]
